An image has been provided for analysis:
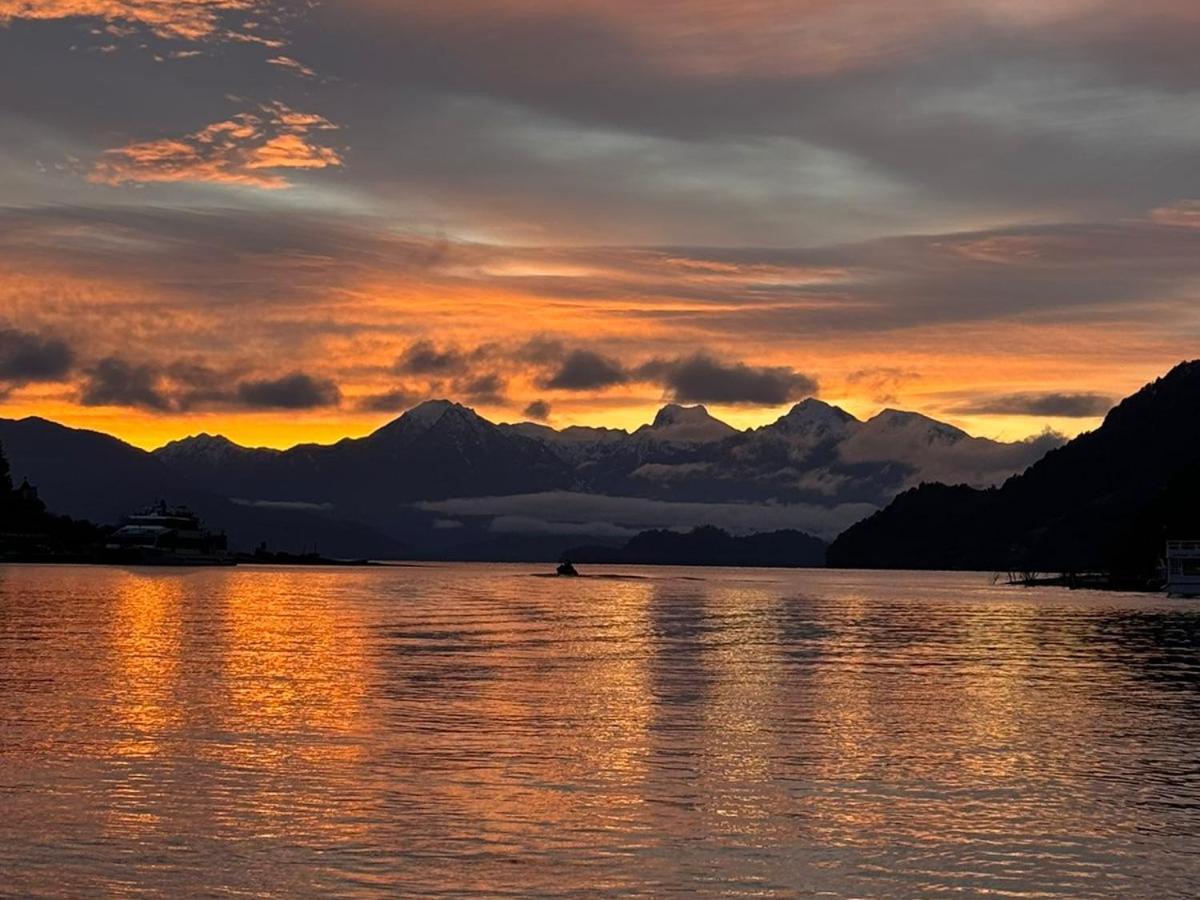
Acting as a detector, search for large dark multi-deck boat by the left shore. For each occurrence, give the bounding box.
[104,500,236,565]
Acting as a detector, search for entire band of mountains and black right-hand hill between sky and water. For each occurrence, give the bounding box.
[0,361,1200,574]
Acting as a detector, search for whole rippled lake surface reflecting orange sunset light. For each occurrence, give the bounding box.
[0,565,1200,898]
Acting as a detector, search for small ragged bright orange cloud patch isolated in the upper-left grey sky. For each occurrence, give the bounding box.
[88,102,342,190]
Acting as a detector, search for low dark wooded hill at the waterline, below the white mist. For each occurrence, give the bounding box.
[563,526,826,569]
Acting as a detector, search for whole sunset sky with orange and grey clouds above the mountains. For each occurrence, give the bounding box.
[0,0,1200,448]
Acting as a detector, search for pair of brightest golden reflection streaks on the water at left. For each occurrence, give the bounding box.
[107,570,368,758]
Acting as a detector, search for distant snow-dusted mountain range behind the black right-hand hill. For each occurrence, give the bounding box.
[0,400,1061,559]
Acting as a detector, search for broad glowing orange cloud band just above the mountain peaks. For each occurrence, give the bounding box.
[0,205,1196,446]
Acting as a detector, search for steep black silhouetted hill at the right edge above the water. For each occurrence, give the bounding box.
[828,361,1200,572]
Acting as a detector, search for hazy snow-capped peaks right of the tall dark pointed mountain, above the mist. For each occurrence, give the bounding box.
[505,398,1062,506]
